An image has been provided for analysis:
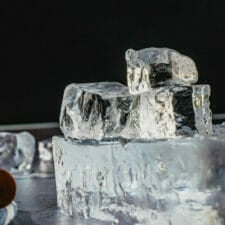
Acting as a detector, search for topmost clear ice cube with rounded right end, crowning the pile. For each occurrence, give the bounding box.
[125,48,198,94]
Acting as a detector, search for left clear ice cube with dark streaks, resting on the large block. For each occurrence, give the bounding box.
[60,82,133,139]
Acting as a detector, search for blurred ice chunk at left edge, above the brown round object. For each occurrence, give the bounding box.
[0,132,35,171]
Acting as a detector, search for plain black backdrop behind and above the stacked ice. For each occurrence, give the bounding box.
[0,1,225,124]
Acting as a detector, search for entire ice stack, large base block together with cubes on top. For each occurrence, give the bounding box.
[53,48,221,225]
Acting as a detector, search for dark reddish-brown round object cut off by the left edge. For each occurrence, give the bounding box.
[0,169,16,208]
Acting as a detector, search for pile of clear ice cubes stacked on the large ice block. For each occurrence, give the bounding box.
[60,48,212,140]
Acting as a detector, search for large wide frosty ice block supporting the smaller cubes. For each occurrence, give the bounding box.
[53,136,225,225]
